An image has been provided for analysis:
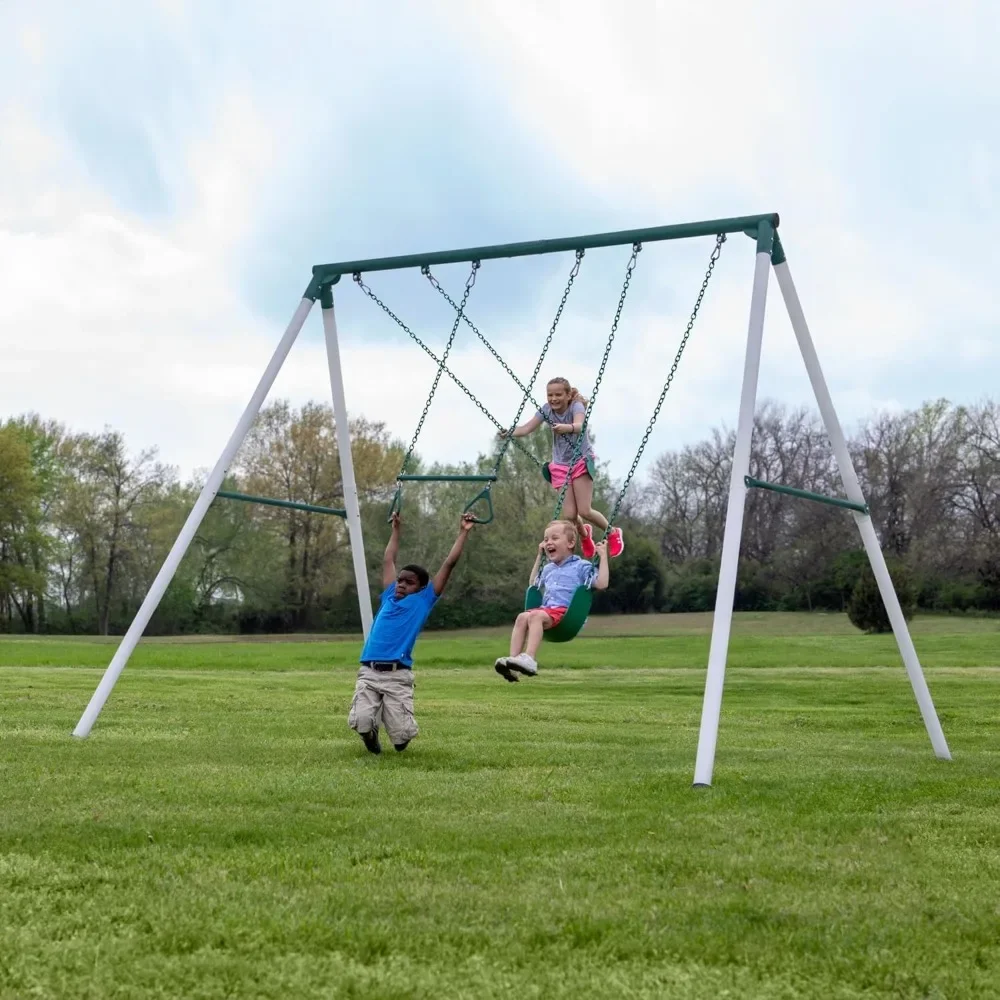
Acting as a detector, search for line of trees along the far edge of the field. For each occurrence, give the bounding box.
[0,400,1000,635]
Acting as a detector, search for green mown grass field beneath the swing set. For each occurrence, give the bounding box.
[0,615,1000,1000]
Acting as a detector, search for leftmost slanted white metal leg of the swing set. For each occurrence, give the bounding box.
[73,298,312,737]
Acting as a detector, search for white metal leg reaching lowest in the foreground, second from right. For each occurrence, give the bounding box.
[694,246,771,785]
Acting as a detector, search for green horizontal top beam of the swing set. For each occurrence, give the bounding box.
[310,212,778,284]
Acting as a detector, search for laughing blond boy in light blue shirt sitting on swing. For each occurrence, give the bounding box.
[494,521,608,682]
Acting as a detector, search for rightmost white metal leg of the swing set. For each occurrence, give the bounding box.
[774,261,951,760]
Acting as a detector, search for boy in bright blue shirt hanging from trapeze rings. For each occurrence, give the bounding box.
[347,511,475,753]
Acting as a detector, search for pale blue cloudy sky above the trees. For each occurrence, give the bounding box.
[0,0,1000,488]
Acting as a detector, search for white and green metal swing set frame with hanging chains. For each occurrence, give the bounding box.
[73,213,951,787]
